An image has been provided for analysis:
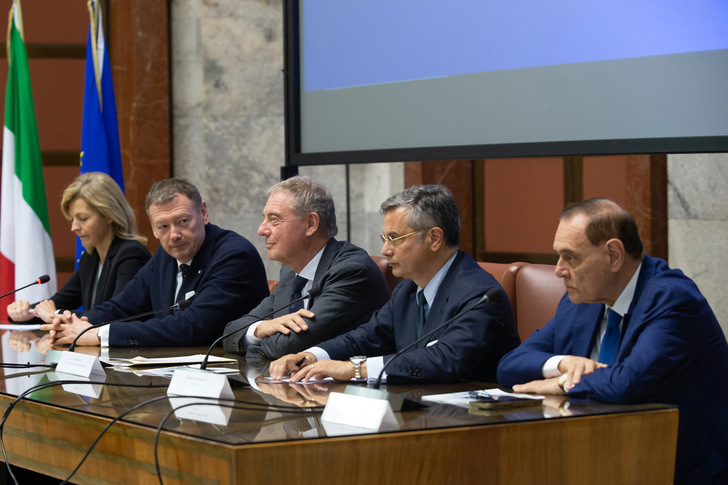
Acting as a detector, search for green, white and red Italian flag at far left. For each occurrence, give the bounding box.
[0,0,56,320]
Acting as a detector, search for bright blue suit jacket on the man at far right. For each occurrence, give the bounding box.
[498,256,728,484]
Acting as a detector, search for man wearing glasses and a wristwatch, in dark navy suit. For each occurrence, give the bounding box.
[270,185,519,382]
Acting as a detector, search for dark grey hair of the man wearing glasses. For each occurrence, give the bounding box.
[379,185,460,248]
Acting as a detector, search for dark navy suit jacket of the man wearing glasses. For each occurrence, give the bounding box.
[319,251,519,383]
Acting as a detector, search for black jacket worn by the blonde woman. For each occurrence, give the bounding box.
[51,237,152,311]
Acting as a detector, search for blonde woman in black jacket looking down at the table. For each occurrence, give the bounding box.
[8,172,151,328]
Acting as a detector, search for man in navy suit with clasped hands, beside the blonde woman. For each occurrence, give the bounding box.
[42,178,268,347]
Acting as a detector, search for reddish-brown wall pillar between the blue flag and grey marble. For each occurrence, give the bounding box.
[107,0,172,251]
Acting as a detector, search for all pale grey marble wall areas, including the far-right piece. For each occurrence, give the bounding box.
[171,0,728,333]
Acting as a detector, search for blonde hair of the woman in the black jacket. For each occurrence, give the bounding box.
[61,172,147,253]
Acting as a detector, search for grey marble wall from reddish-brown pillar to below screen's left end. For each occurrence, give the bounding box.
[171,0,404,279]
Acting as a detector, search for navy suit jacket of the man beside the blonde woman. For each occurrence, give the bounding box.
[86,224,268,347]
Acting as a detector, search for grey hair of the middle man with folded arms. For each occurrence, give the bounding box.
[266,175,339,238]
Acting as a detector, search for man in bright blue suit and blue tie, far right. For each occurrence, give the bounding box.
[498,199,728,484]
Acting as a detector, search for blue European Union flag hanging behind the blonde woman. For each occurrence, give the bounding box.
[76,1,124,267]
